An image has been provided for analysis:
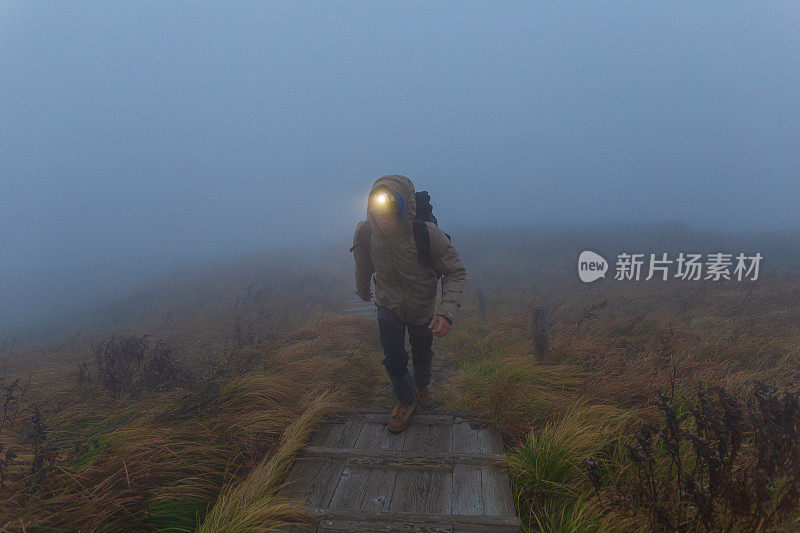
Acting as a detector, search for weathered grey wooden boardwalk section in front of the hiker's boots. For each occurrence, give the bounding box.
[286,408,519,532]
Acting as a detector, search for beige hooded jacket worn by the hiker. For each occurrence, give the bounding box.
[353,176,466,325]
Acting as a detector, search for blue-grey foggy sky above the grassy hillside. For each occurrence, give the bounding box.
[0,1,800,325]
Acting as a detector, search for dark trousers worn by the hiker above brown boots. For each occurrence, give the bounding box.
[376,304,433,405]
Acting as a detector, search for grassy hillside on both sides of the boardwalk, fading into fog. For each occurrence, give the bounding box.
[0,222,800,531]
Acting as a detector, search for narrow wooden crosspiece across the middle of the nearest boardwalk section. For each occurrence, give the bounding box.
[298,446,505,467]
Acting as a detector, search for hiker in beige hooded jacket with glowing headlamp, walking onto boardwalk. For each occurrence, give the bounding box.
[350,175,466,433]
